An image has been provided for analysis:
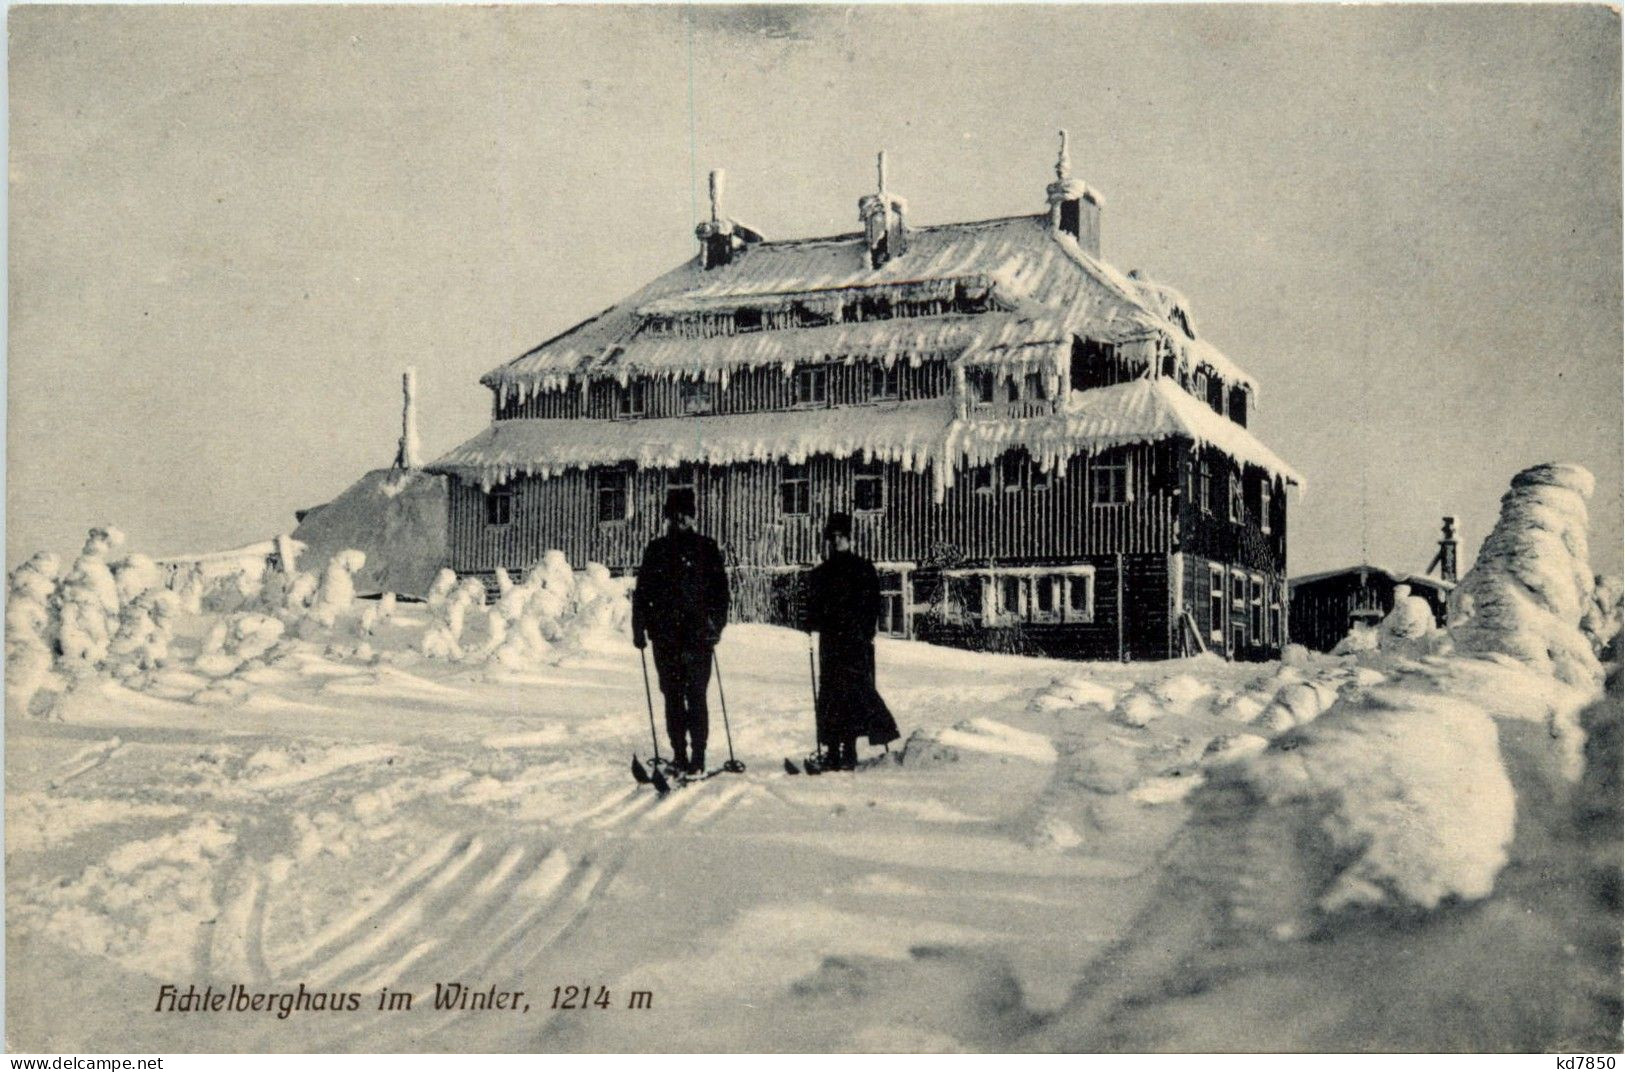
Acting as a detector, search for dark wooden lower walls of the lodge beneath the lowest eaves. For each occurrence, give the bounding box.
[450,422,1285,659]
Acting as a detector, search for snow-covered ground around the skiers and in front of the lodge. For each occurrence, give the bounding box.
[7,473,1622,1051]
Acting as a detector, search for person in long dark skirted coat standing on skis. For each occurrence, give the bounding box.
[808,513,897,770]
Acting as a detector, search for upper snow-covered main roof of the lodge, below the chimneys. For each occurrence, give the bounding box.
[481,216,1256,396]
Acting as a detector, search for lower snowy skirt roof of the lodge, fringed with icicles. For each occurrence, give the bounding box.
[427,378,1303,494]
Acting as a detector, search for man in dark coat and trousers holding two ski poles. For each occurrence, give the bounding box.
[632,489,728,773]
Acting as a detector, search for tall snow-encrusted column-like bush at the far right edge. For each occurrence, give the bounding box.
[1450,465,1602,685]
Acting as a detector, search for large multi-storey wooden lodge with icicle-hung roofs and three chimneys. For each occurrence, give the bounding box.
[427,135,1300,658]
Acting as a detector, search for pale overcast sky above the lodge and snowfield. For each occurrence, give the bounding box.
[7,6,1622,573]
